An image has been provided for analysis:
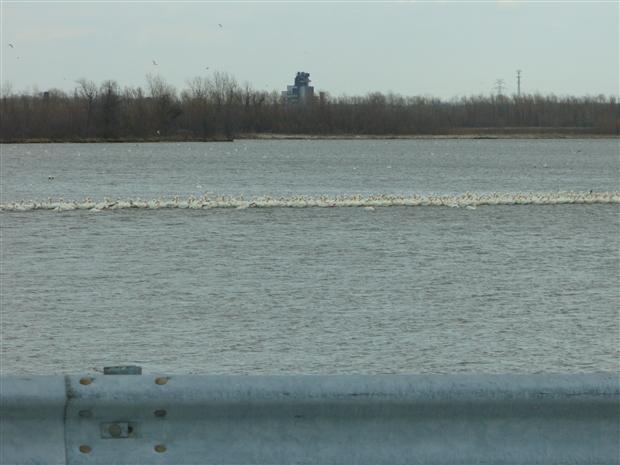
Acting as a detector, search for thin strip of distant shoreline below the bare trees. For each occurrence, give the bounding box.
[0,132,620,145]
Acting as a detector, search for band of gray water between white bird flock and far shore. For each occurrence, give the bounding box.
[1,139,620,198]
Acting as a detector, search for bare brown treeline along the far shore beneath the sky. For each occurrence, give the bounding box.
[0,72,620,142]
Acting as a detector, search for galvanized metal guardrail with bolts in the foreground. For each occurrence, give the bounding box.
[0,370,620,465]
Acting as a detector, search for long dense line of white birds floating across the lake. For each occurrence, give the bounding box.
[0,191,620,212]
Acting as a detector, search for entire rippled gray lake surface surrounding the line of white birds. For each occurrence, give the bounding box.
[0,139,620,374]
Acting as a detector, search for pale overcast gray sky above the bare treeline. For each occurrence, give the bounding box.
[0,0,620,98]
